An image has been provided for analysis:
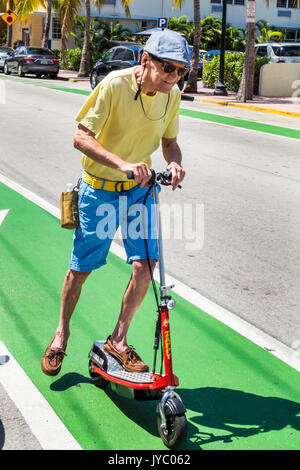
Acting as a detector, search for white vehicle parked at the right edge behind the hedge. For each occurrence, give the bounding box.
[255,42,300,63]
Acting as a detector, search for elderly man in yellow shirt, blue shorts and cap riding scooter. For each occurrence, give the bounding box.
[42,31,190,376]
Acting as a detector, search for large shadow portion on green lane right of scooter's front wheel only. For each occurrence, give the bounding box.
[179,387,300,449]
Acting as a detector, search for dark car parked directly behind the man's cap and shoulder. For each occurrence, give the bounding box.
[90,44,184,89]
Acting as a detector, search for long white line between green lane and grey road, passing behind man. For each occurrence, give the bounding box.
[0,174,300,372]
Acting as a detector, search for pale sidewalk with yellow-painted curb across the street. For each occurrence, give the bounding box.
[58,70,300,117]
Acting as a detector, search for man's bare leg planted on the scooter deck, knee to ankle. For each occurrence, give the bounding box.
[110,260,156,352]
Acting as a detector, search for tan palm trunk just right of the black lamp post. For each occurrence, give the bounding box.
[237,18,255,103]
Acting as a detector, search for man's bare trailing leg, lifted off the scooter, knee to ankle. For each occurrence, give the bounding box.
[51,269,91,351]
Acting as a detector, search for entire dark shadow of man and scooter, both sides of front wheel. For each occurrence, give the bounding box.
[51,373,300,450]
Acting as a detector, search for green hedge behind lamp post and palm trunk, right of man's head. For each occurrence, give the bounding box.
[203,53,268,94]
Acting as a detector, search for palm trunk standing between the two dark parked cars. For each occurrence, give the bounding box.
[78,0,132,77]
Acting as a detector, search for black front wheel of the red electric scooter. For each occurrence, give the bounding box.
[157,406,187,449]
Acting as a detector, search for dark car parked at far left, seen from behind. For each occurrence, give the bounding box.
[4,46,59,78]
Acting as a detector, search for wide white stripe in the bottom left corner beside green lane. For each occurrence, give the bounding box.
[0,341,81,450]
